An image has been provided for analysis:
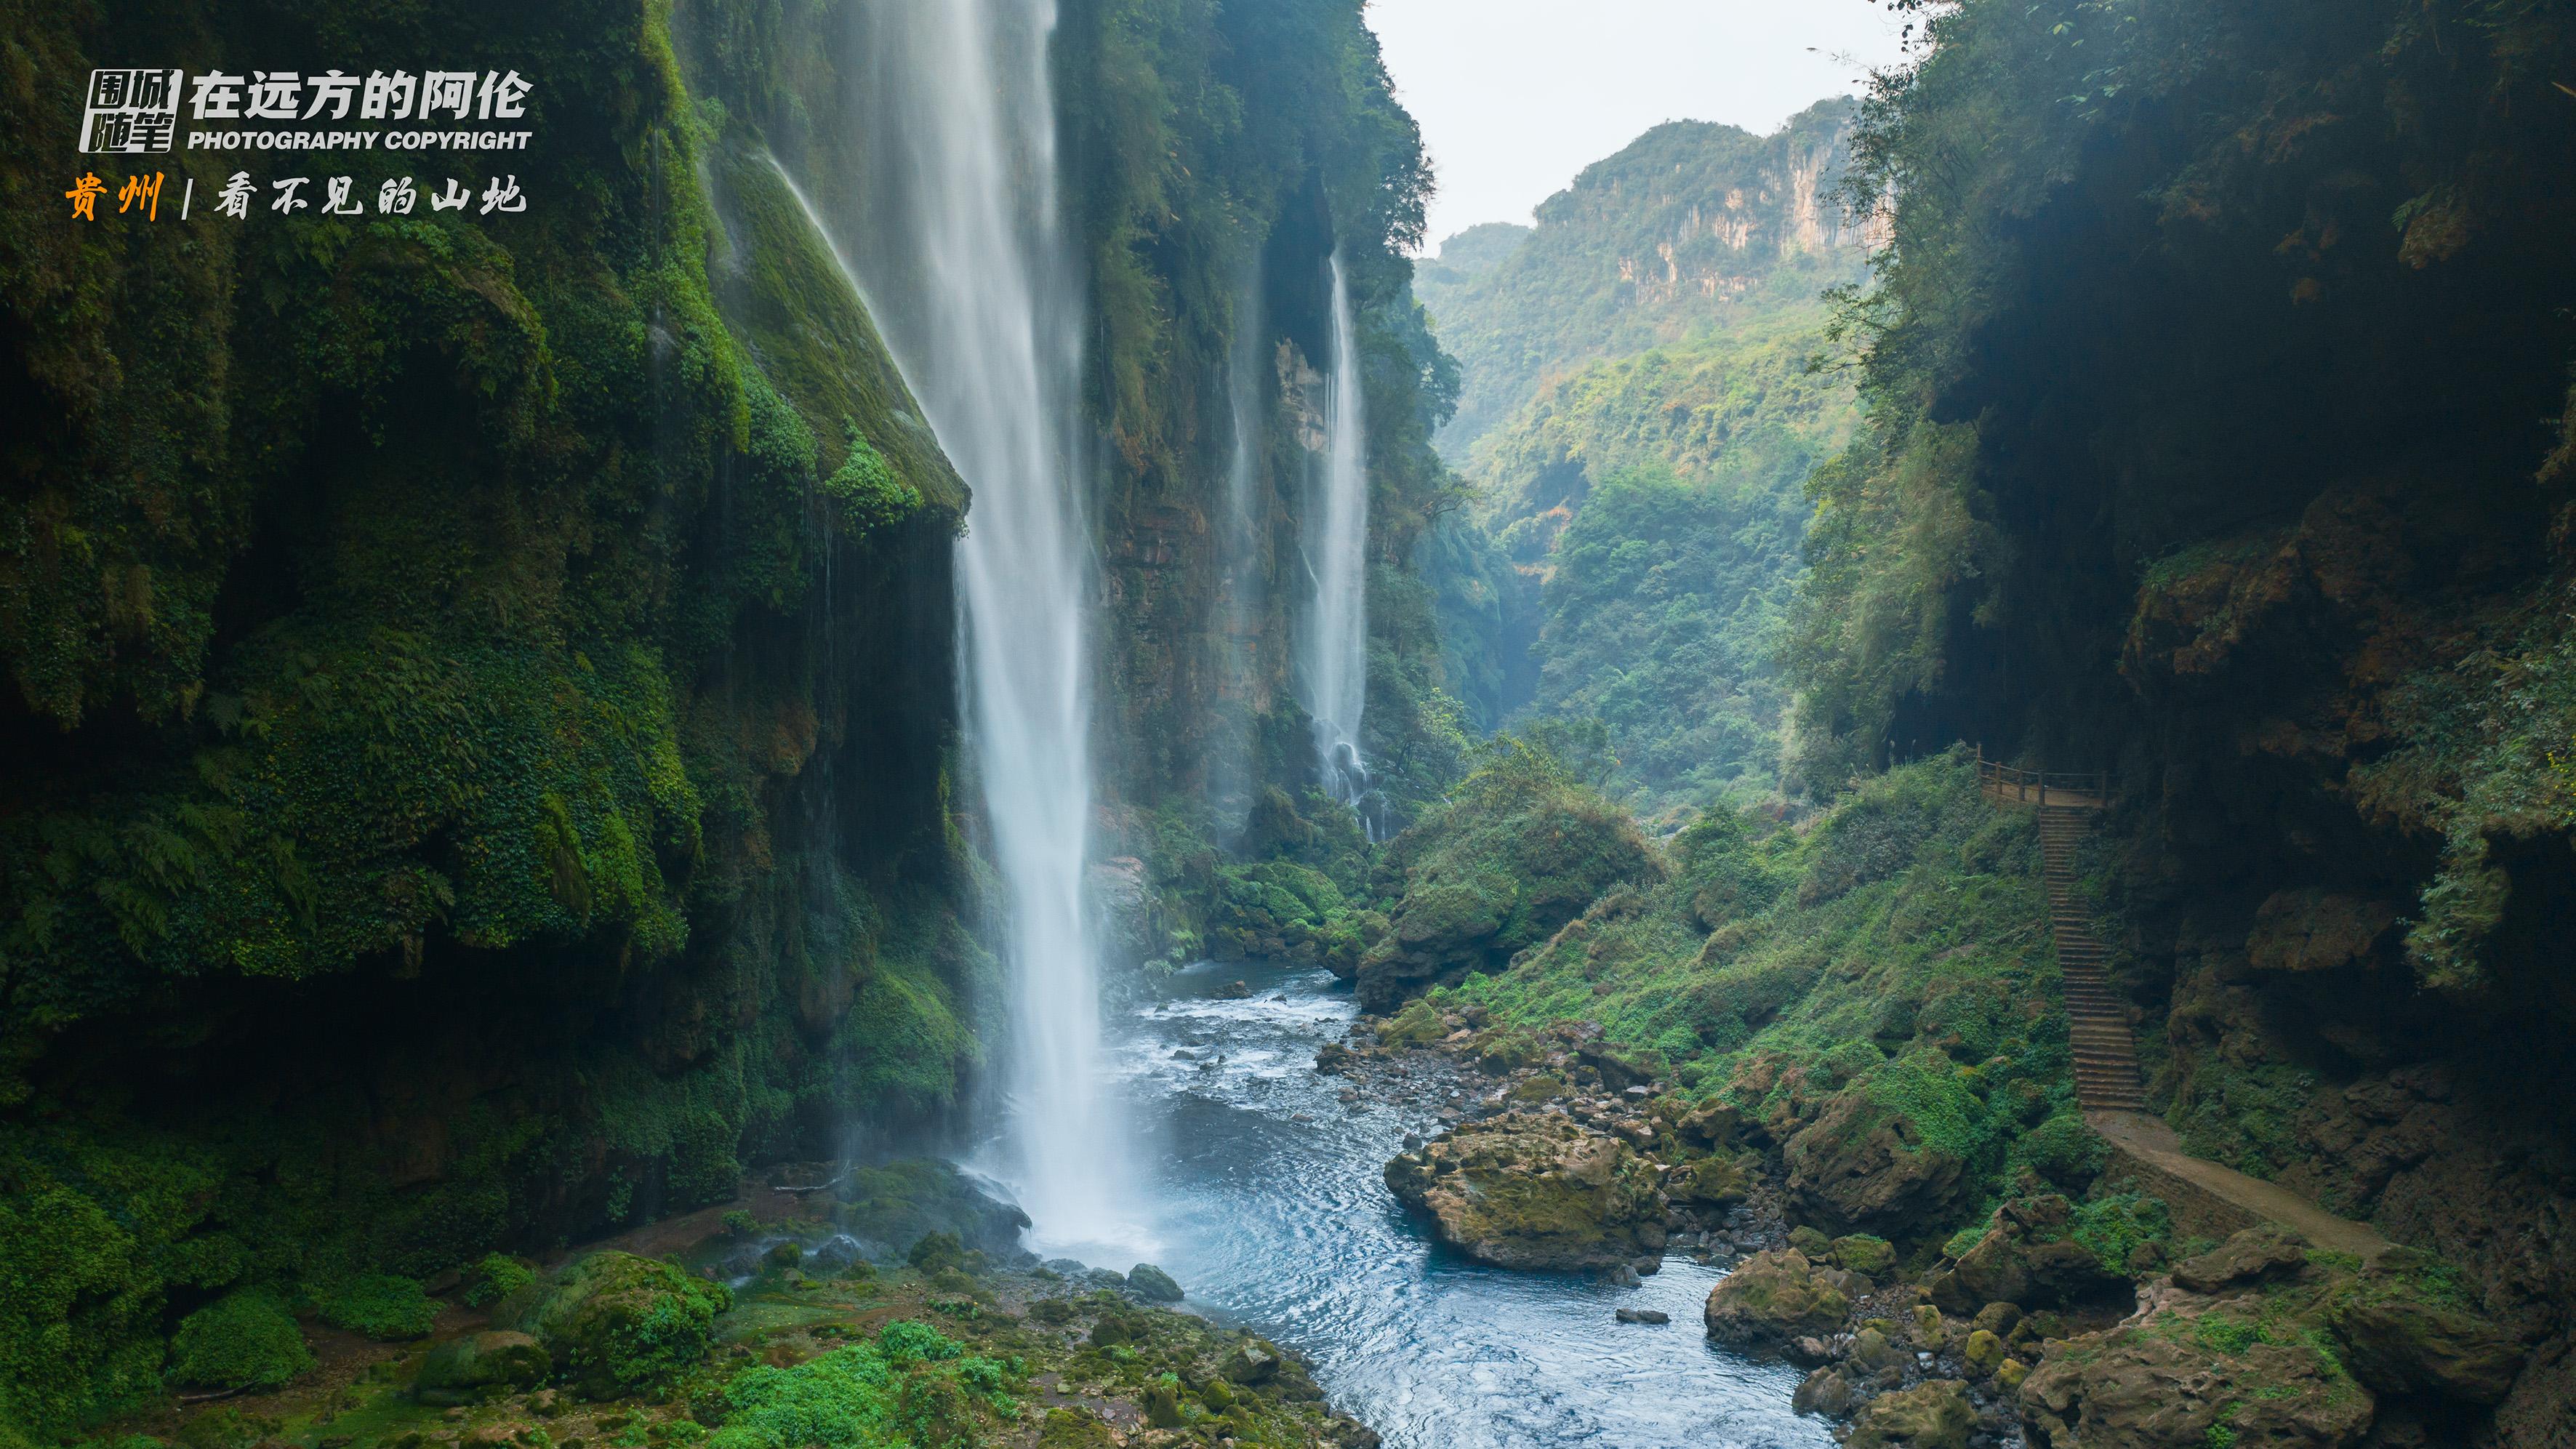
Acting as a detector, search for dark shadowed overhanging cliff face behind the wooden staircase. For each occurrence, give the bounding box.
[1793,0,2576,1441]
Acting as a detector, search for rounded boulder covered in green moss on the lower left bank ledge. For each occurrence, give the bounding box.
[497,1251,734,1397]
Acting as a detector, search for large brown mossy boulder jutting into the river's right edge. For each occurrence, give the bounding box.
[1386,1112,1664,1269]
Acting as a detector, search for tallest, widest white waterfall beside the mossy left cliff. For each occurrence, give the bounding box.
[824,0,1126,1245]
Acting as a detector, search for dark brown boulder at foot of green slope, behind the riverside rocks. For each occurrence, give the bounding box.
[1785,1086,1973,1235]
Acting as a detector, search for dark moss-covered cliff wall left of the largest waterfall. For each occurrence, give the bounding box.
[0,0,990,1434]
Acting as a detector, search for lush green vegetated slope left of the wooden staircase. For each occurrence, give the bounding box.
[1363,742,2081,1253]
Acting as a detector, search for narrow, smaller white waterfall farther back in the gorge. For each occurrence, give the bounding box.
[1299,249,1376,836]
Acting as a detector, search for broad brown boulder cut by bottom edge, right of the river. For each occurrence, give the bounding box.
[1999,1305,2375,1449]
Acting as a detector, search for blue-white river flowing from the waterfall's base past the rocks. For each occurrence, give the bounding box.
[1110,965,1831,1449]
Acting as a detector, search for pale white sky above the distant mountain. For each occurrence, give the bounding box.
[1368,0,1898,252]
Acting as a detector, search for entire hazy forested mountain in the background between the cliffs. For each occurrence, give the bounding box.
[1414,100,1865,811]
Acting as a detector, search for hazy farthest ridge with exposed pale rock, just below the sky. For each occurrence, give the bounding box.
[1417,100,1868,466]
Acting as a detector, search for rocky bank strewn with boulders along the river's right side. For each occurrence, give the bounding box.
[1349,1001,2524,1449]
